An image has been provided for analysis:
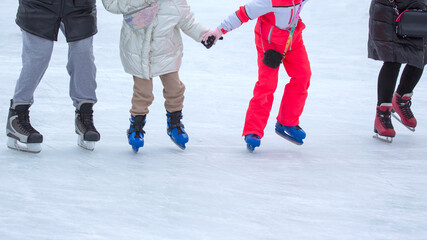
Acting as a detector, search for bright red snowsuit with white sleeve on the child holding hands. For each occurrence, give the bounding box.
[218,0,311,138]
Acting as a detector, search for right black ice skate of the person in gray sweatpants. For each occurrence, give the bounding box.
[75,102,100,151]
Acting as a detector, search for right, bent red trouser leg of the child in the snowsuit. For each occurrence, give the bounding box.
[277,38,311,126]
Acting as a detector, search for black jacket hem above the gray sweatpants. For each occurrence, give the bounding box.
[16,0,97,42]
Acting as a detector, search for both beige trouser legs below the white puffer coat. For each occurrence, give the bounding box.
[130,72,185,116]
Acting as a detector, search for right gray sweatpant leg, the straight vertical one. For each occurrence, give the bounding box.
[67,37,97,107]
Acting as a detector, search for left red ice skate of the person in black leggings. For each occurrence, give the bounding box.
[374,103,396,143]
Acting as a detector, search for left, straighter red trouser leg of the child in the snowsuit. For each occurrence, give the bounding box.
[243,47,279,138]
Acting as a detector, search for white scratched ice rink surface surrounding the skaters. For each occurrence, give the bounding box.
[0,0,427,240]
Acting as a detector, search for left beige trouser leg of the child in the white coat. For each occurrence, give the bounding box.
[130,76,154,116]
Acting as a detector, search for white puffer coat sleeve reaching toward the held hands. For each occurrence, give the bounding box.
[176,0,209,42]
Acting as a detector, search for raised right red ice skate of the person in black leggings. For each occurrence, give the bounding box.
[392,93,417,132]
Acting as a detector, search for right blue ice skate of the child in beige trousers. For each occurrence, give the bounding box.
[166,111,188,150]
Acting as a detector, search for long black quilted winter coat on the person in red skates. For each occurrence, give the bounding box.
[368,0,427,68]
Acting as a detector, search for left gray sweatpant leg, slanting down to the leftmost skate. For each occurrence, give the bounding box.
[13,30,53,104]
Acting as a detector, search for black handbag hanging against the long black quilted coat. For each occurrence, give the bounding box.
[396,9,427,38]
